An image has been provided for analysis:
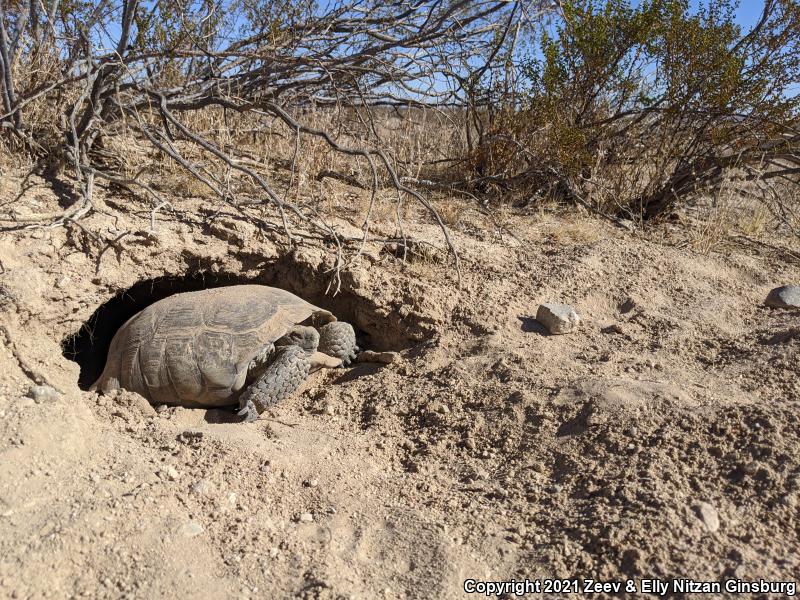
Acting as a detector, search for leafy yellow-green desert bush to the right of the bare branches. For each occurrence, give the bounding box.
[469,0,800,220]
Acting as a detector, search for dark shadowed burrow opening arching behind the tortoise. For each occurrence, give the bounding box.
[61,272,416,390]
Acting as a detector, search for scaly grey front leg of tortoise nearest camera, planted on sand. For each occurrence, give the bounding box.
[238,346,311,423]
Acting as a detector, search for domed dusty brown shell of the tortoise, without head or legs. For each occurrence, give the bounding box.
[92,285,336,406]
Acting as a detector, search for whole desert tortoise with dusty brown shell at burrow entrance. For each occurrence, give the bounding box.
[91,285,358,421]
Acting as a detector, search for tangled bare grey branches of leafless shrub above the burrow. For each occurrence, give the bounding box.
[0,0,556,286]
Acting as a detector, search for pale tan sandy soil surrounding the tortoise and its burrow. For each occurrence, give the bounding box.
[0,171,800,598]
